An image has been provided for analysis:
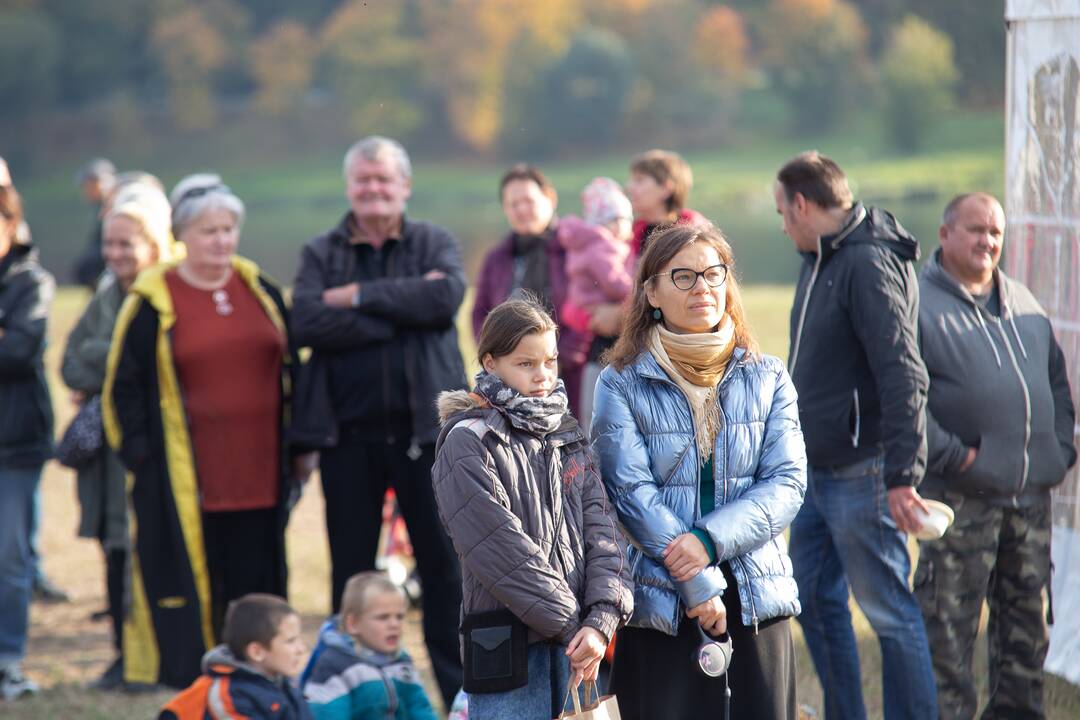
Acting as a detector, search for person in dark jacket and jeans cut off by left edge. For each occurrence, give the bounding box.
[0,177,56,701]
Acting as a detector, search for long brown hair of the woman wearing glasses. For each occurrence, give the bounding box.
[604,225,759,370]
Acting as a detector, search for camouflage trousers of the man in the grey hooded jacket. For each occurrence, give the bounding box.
[915,492,1051,720]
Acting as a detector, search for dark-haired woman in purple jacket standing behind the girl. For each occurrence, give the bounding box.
[472,163,589,415]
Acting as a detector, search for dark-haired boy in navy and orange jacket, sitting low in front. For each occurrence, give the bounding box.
[158,593,311,720]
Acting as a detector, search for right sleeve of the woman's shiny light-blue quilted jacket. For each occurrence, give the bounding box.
[697,361,807,562]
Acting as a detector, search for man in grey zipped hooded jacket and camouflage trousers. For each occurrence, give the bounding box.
[915,193,1077,720]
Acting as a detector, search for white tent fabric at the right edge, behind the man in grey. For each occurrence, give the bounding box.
[1005,0,1080,683]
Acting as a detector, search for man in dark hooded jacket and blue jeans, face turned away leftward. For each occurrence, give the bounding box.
[775,152,937,720]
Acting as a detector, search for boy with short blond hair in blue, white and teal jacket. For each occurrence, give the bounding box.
[300,572,435,720]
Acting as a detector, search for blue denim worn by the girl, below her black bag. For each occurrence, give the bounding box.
[469,642,573,720]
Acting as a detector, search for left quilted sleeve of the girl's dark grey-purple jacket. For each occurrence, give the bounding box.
[431,423,579,644]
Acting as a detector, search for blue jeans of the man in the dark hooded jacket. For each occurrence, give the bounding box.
[791,456,937,720]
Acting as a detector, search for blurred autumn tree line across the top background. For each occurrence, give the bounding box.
[0,0,1004,166]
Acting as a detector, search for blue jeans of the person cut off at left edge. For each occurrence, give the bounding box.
[0,465,41,665]
